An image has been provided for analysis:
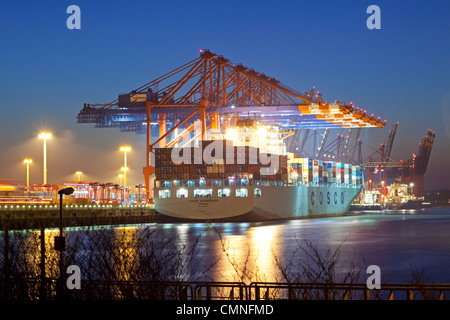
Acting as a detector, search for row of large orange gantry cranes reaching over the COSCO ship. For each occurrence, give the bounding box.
[77,50,386,198]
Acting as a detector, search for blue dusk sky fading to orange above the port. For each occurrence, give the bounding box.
[0,0,450,191]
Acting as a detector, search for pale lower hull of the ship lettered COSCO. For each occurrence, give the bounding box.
[155,185,361,221]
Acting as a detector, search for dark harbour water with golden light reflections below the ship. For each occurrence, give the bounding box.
[3,208,450,283]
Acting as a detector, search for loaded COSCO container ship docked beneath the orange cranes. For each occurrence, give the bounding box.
[154,126,362,221]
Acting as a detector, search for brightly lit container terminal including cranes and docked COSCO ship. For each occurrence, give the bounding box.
[0,50,435,219]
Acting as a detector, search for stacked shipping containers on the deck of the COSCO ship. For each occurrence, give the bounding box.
[155,141,362,184]
